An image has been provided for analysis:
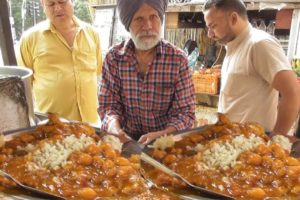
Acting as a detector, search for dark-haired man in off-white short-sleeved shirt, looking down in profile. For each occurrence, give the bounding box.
[204,0,300,136]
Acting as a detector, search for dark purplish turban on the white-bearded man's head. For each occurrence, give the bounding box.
[117,0,168,31]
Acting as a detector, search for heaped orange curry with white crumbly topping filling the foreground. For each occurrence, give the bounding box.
[0,115,300,200]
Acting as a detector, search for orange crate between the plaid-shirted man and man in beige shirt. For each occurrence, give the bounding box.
[193,72,220,94]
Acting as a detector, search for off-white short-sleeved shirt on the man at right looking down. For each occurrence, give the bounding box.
[218,24,291,131]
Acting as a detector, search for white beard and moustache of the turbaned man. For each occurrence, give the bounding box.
[129,29,161,51]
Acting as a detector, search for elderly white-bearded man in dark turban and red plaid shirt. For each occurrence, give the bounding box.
[99,0,195,144]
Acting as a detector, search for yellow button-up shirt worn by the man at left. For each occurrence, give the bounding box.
[17,17,102,123]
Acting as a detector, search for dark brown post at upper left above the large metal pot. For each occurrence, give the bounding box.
[0,0,17,65]
